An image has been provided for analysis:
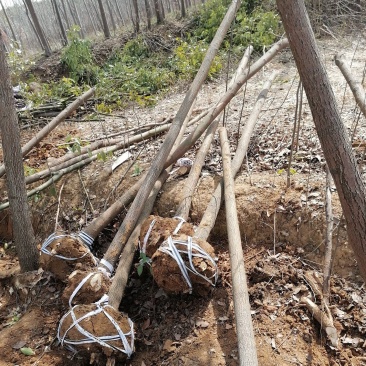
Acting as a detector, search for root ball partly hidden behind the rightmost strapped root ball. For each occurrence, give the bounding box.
[140,215,194,258]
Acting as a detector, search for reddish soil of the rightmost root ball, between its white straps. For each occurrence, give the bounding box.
[151,235,217,295]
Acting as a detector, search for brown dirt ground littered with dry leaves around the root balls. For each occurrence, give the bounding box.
[0,29,366,366]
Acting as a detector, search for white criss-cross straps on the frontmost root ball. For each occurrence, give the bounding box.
[57,295,134,357]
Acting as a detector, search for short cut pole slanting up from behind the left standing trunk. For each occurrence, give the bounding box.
[0,88,95,178]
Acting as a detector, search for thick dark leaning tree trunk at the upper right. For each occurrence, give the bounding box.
[277,0,366,280]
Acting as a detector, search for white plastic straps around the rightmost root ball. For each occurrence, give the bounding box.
[159,236,218,292]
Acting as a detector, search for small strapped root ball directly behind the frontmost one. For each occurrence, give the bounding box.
[62,270,111,306]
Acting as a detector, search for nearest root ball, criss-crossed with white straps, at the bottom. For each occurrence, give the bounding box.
[57,297,134,359]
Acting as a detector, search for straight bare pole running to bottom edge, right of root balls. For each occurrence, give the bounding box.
[219,127,258,366]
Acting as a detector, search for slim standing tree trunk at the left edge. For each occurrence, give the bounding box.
[0,32,39,272]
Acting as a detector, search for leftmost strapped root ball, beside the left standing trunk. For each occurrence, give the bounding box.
[40,234,97,282]
